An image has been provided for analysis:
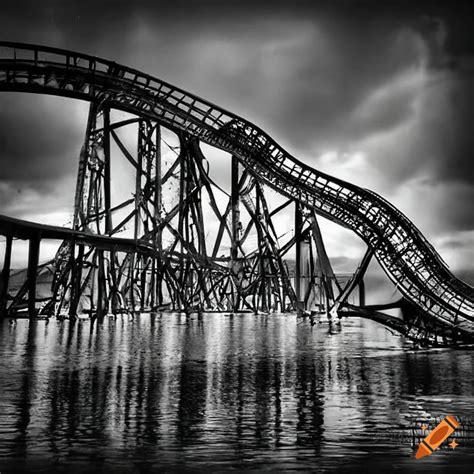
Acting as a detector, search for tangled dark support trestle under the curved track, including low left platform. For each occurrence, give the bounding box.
[0,103,365,317]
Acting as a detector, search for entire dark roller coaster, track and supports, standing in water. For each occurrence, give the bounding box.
[0,42,474,345]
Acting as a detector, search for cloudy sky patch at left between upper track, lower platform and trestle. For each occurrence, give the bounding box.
[0,93,87,217]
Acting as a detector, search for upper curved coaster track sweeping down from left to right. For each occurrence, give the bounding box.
[0,42,474,338]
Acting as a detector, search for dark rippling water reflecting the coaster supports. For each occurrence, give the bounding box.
[0,314,474,474]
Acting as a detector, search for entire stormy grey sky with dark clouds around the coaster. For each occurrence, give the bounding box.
[0,0,474,283]
